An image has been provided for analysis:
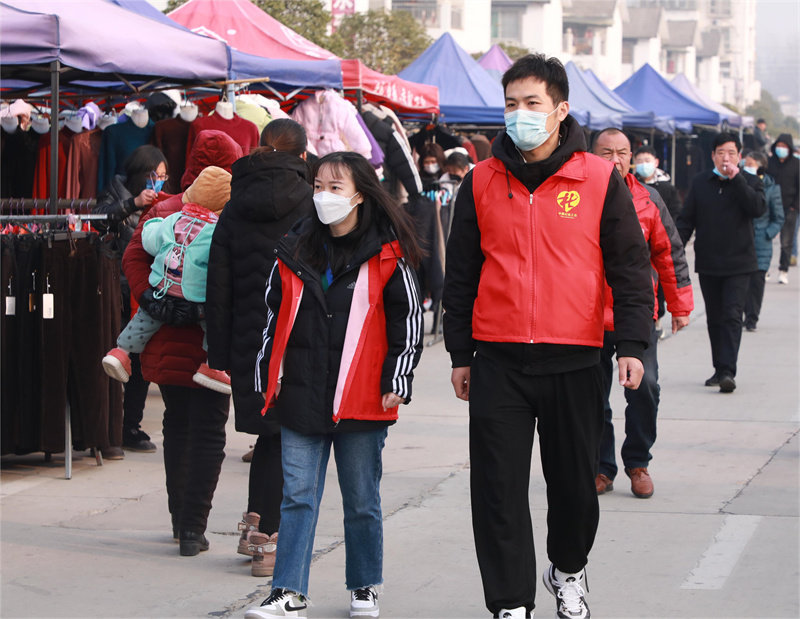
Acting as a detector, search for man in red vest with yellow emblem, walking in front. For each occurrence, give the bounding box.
[444,54,653,619]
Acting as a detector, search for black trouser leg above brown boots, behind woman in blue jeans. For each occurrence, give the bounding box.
[247,434,283,535]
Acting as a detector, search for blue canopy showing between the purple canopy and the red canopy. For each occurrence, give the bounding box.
[110,0,342,91]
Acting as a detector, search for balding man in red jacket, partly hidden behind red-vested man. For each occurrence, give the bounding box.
[592,127,694,499]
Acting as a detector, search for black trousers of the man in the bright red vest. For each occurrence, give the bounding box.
[469,354,604,613]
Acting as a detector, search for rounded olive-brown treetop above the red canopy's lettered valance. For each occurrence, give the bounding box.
[328,11,433,75]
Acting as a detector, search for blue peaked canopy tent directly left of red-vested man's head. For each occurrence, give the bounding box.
[397,32,505,125]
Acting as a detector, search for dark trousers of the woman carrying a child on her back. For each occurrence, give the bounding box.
[158,385,230,533]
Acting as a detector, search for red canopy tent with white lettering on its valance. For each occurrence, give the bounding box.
[168,0,439,114]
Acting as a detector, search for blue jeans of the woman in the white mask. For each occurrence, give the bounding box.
[272,428,387,595]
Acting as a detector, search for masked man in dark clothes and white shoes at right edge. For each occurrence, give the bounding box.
[768,133,800,284]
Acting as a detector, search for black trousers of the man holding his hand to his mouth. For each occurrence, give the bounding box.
[700,274,752,377]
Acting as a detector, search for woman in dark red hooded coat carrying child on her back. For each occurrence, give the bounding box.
[122,131,242,556]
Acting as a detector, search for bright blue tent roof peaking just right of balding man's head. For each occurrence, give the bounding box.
[614,64,723,132]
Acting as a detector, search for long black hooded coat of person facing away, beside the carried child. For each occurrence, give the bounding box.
[206,152,314,434]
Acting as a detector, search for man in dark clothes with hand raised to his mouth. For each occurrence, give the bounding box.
[677,133,767,393]
